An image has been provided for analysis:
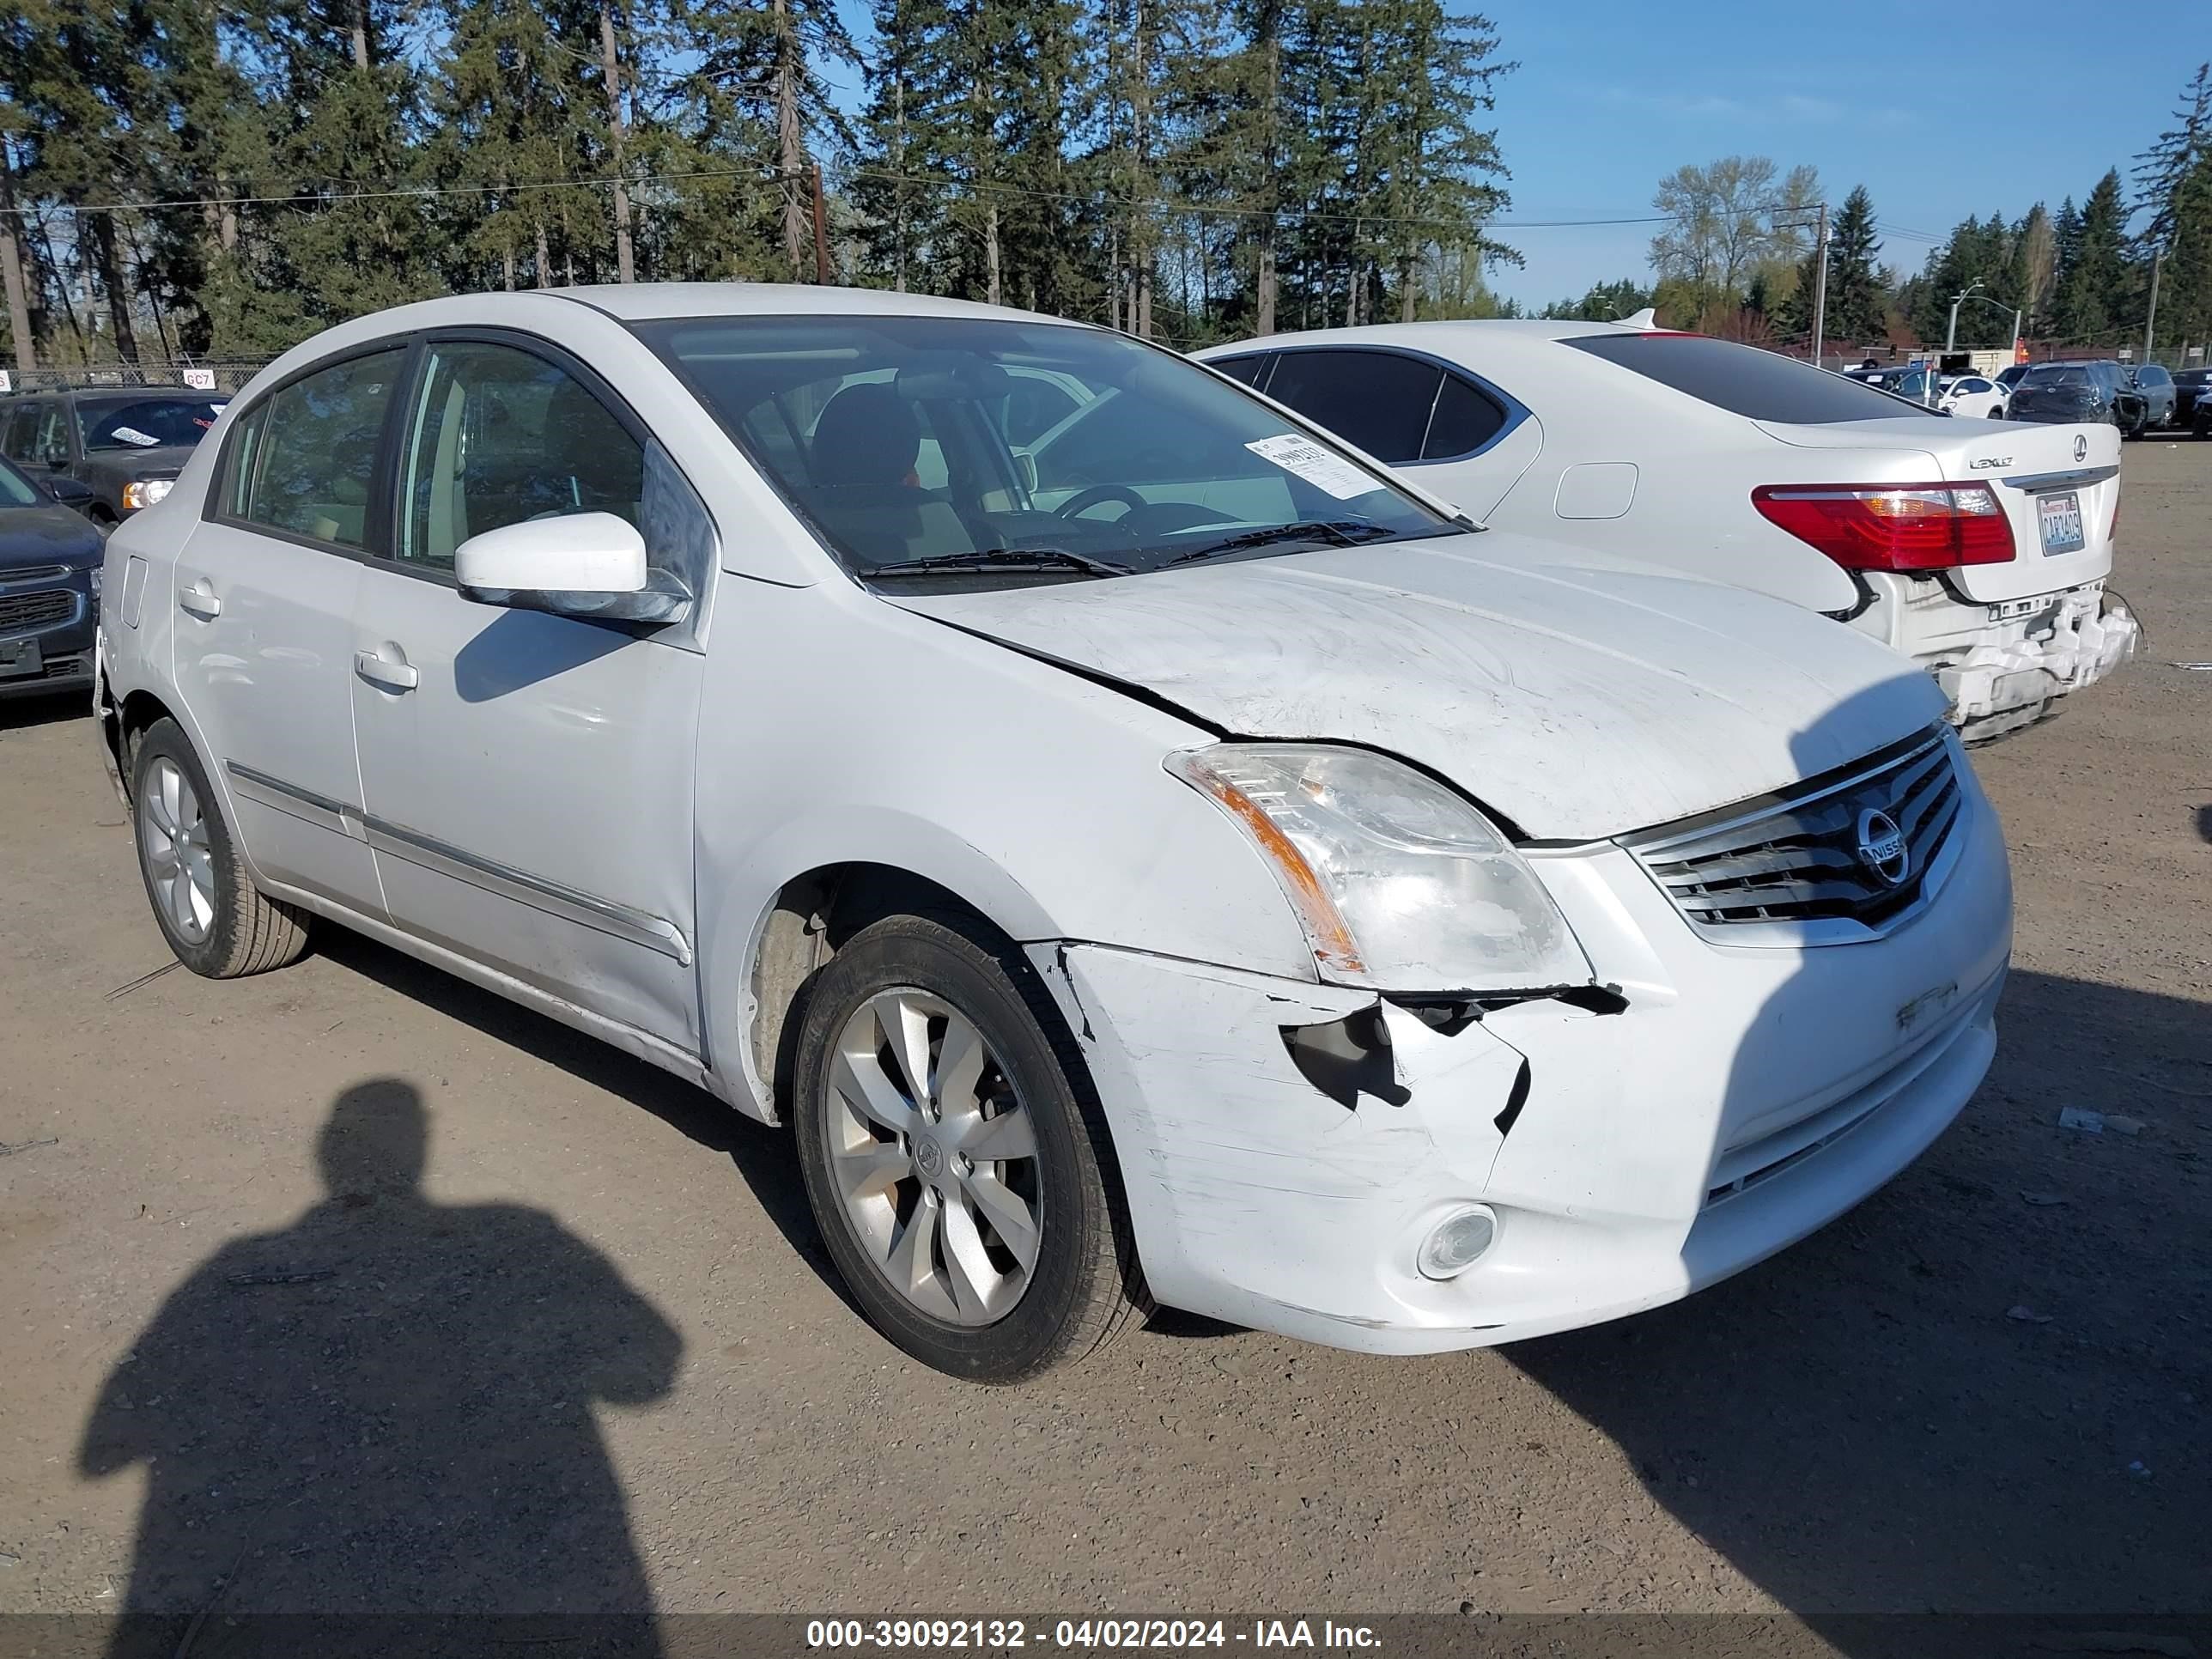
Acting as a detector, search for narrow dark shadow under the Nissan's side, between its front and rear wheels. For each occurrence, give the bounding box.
[314,927,858,1314]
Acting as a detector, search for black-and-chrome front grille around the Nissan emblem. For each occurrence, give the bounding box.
[1624,728,1964,938]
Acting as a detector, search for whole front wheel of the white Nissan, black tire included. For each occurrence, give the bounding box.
[792,915,1151,1382]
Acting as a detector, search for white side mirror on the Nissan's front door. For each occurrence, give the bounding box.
[453,514,692,622]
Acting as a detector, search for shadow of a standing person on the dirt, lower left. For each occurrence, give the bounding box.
[77,1078,684,1659]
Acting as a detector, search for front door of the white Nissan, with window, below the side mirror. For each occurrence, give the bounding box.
[352,338,712,1055]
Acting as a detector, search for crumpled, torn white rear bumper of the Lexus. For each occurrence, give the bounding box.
[1905,581,2143,744]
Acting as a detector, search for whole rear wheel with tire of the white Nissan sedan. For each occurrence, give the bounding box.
[131,719,307,980]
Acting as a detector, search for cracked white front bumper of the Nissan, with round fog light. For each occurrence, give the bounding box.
[1030,792,2011,1354]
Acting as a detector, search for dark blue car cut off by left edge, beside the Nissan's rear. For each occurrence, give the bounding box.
[0,448,100,696]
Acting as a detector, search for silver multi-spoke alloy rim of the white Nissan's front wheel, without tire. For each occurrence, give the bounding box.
[823,988,1044,1325]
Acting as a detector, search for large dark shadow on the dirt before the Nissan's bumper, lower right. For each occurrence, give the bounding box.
[1502,973,2212,1656]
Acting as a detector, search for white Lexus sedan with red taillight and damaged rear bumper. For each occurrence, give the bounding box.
[1199,321,2139,738]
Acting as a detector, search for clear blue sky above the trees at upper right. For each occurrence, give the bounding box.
[834,0,2212,305]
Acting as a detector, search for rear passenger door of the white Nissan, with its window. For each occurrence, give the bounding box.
[172,349,407,915]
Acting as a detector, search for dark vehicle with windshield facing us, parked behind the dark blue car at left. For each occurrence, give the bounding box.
[0,387,223,529]
